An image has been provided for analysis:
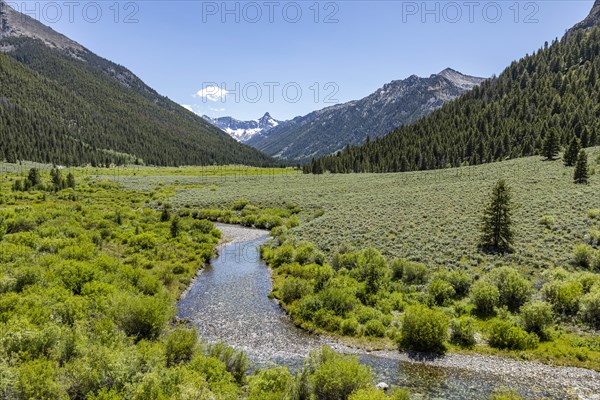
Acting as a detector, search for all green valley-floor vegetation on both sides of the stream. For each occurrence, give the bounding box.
[0,149,600,399]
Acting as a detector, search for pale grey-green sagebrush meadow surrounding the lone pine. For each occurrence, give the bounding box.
[103,148,600,272]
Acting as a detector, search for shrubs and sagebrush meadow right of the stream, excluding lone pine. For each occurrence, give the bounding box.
[139,149,600,370]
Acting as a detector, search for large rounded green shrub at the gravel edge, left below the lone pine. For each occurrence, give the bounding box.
[399,306,448,353]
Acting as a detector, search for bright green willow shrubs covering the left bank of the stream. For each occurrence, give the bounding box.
[0,165,407,400]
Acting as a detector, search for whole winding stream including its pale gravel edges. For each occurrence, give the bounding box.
[178,225,600,400]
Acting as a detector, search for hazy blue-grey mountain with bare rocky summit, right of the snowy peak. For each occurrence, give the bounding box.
[247,69,483,161]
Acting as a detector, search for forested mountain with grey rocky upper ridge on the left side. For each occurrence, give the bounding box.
[0,0,274,166]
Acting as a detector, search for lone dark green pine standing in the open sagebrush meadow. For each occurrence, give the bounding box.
[481,179,514,250]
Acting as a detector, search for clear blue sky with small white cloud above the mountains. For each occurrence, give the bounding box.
[15,0,593,119]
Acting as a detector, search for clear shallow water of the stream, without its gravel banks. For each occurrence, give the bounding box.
[178,235,592,399]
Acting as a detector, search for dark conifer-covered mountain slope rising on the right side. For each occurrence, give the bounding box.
[306,1,600,173]
